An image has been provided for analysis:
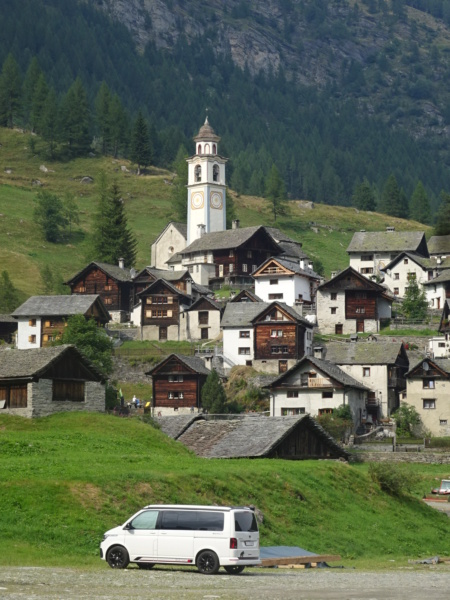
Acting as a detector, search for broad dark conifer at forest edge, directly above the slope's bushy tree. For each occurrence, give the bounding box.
[60,77,92,157]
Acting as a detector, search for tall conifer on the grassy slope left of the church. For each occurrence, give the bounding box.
[93,175,137,267]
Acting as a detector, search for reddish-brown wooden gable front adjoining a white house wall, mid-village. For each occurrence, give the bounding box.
[253,305,306,360]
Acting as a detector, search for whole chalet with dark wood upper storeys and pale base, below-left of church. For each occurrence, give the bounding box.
[133,279,192,341]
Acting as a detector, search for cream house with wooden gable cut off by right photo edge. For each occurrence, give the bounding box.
[405,358,450,437]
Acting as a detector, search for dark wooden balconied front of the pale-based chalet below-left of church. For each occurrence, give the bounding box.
[139,279,190,327]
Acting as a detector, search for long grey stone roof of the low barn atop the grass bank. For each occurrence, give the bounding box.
[173,415,346,458]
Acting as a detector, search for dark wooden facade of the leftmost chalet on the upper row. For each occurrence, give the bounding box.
[67,263,133,312]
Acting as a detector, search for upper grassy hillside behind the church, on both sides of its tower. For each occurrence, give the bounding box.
[0,129,431,296]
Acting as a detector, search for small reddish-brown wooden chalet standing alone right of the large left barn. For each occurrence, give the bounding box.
[150,355,207,411]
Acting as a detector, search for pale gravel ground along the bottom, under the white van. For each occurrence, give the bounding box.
[0,564,450,600]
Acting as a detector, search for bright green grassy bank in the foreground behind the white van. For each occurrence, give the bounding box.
[0,413,450,567]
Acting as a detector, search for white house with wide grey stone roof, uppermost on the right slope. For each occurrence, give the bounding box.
[347,227,429,278]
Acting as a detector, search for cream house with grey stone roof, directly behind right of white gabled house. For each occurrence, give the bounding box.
[314,338,409,422]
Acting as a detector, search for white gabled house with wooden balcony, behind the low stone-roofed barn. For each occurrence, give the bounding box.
[265,356,369,428]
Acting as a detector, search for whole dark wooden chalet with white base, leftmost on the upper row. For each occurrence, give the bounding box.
[65,262,133,322]
